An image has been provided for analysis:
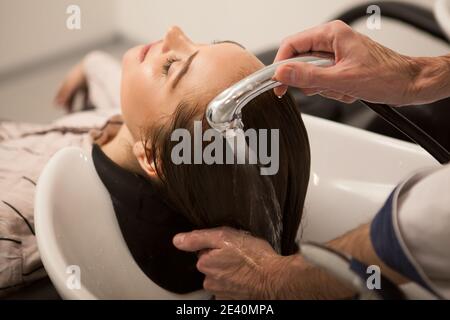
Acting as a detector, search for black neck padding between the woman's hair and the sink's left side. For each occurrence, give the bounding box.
[92,145,204,293]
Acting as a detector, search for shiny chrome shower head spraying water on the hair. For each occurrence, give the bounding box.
[206,56,334,133]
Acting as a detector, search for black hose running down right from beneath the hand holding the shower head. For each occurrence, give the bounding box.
[361,101,450,164]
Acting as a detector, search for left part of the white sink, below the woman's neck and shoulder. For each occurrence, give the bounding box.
[35,147,209,299]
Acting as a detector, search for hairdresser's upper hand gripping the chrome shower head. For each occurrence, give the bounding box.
[275,21,424,105]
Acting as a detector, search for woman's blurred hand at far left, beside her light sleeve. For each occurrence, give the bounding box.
[54,62,86,112]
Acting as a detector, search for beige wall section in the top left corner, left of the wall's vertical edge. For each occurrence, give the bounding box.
[0,0,116,72]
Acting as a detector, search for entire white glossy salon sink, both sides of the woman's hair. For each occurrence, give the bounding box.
[35,116,438,299]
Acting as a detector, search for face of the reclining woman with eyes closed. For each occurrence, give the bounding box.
[121,27,263,139]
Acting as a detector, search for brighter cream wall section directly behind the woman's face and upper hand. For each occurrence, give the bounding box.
[116,0,448,55]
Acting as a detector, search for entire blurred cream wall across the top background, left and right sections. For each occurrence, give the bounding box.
[0,0,449,75]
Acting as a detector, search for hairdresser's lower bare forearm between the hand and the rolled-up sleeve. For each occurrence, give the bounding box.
[273,224,406,300]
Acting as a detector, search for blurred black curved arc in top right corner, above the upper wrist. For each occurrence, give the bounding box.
[334,1,448,43]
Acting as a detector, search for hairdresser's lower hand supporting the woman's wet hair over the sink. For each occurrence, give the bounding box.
[173,228,289,299]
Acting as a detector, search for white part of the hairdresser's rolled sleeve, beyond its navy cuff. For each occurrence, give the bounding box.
[396,165,450,299]
